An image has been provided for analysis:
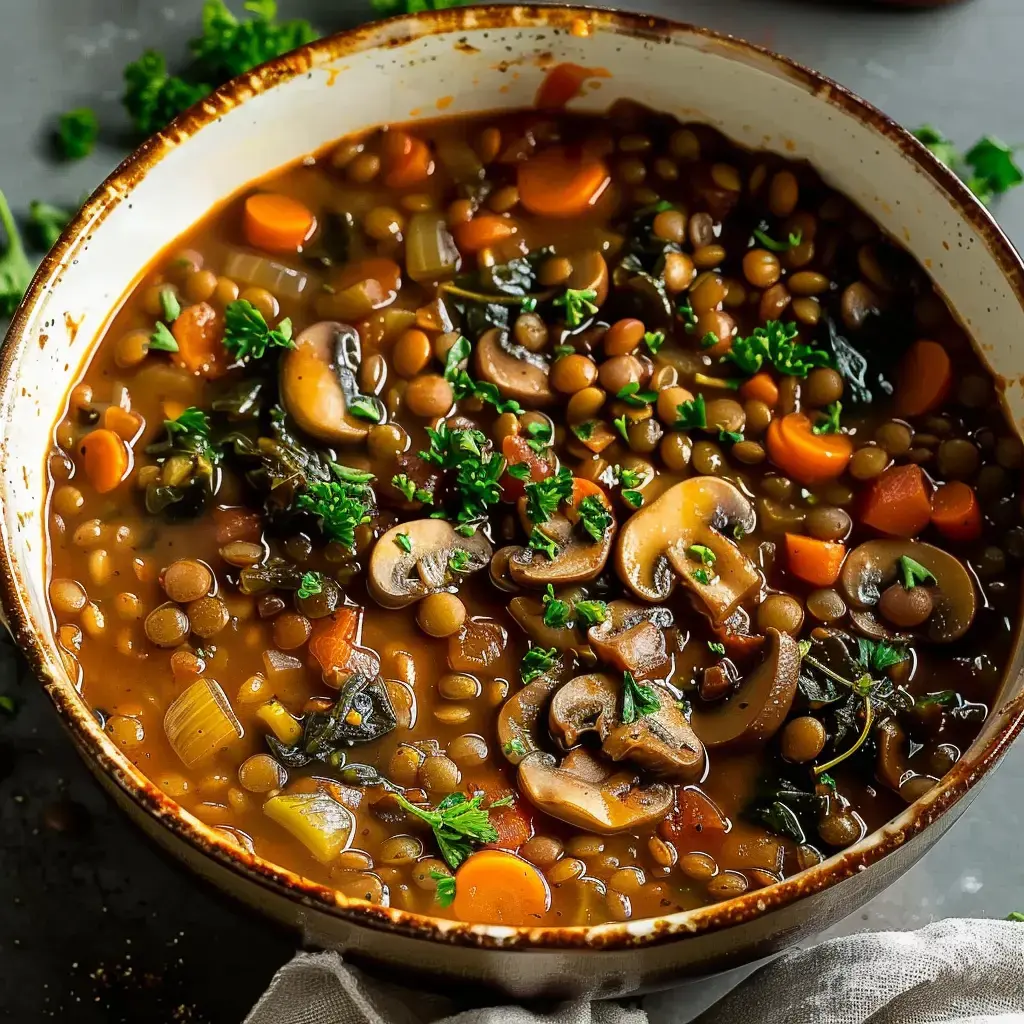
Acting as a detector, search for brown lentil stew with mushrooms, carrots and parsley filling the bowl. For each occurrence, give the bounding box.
[49,103,1024,926]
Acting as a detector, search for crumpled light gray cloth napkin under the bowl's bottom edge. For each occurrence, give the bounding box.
[246,920,1024,1024]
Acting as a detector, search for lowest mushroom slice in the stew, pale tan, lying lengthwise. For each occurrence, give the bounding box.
[519,751,674,836]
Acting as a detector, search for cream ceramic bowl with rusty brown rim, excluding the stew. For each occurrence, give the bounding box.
[0,6,1024,998]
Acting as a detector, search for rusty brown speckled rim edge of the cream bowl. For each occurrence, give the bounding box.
[6,4,1024,951]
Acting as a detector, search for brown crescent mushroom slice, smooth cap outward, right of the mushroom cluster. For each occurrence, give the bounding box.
[690,629,800,751]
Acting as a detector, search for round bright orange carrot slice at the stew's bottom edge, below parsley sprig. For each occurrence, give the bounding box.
[452,850,551,926]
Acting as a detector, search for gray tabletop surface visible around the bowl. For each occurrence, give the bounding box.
[0,0,1024,1024]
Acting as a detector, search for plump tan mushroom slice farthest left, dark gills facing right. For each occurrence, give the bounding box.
[281,321,376,444]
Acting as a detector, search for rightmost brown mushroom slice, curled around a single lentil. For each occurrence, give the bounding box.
[840,540,978,643]
